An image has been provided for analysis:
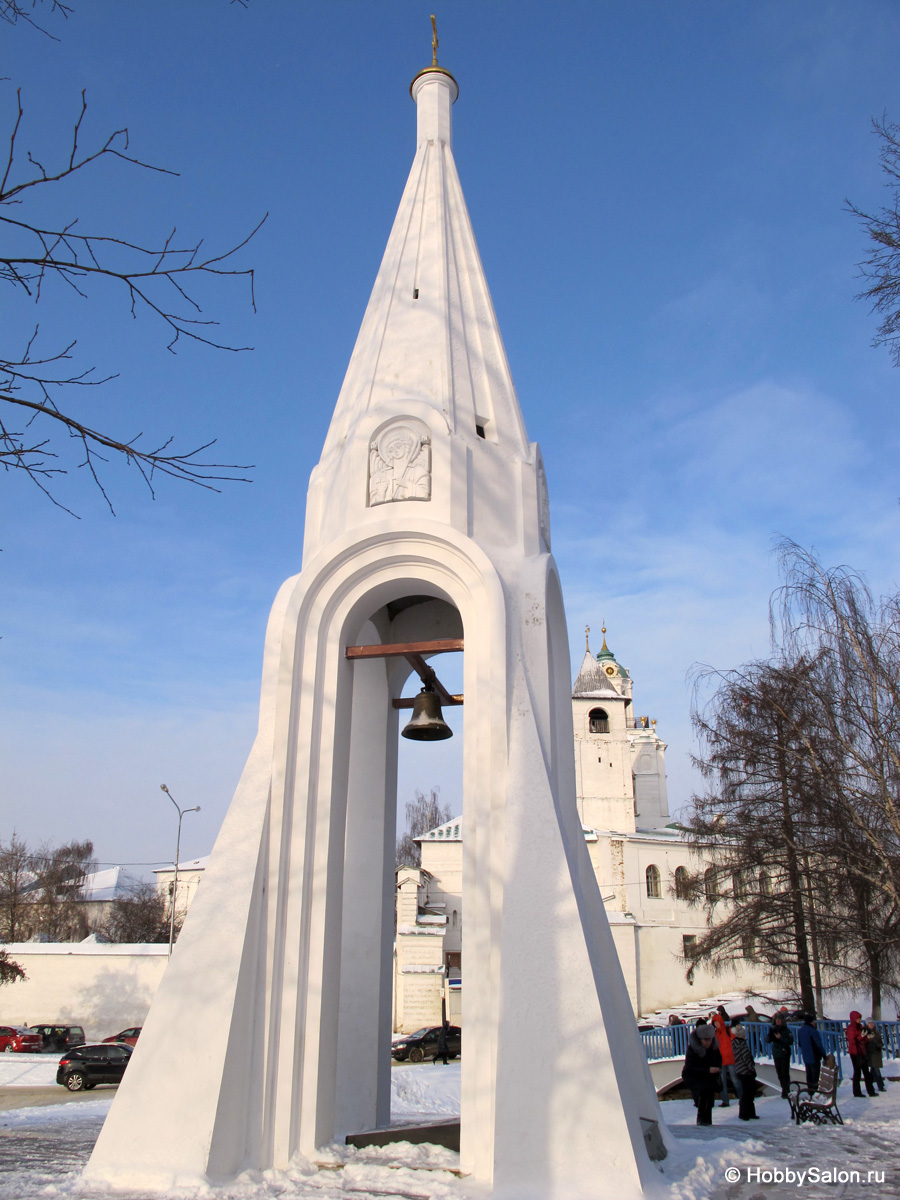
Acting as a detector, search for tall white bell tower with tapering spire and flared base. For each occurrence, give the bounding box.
[86,42,660,1200]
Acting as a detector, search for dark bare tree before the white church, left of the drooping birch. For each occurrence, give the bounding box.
[688,662,835,1010]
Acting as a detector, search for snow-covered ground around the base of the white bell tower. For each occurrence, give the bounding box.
[0,1055,900,1200]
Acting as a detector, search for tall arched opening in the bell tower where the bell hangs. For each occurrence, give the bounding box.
[336,584,464,1132]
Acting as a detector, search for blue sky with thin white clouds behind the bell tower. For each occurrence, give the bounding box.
[0,0,900,863]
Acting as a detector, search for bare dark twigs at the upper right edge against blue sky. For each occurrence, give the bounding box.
[846,115,900,366]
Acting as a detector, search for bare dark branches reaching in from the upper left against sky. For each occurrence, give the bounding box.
[0,0,265,511]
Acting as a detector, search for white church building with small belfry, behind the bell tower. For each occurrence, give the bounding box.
[394,628,770,1033]
